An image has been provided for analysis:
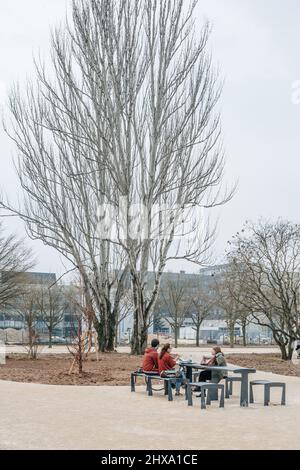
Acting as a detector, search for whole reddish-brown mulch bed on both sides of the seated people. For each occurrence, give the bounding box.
[0,353,300,385]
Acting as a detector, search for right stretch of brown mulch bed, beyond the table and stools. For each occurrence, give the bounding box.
[226,353,300,377]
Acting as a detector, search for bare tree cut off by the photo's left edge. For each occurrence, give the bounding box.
[0,222,34,306]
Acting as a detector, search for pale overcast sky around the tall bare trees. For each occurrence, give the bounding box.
[0,0,300,273]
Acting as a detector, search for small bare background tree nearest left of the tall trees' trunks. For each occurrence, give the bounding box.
[37,285,67,348]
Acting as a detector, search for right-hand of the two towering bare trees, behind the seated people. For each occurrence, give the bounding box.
[67,0,232,354]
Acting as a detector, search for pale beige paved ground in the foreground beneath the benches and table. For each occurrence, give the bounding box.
[0,373,300,450]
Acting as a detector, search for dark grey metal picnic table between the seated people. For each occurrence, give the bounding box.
[179,361,256,407]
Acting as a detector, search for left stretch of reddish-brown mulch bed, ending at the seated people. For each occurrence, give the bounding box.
[0,353,141,385]
